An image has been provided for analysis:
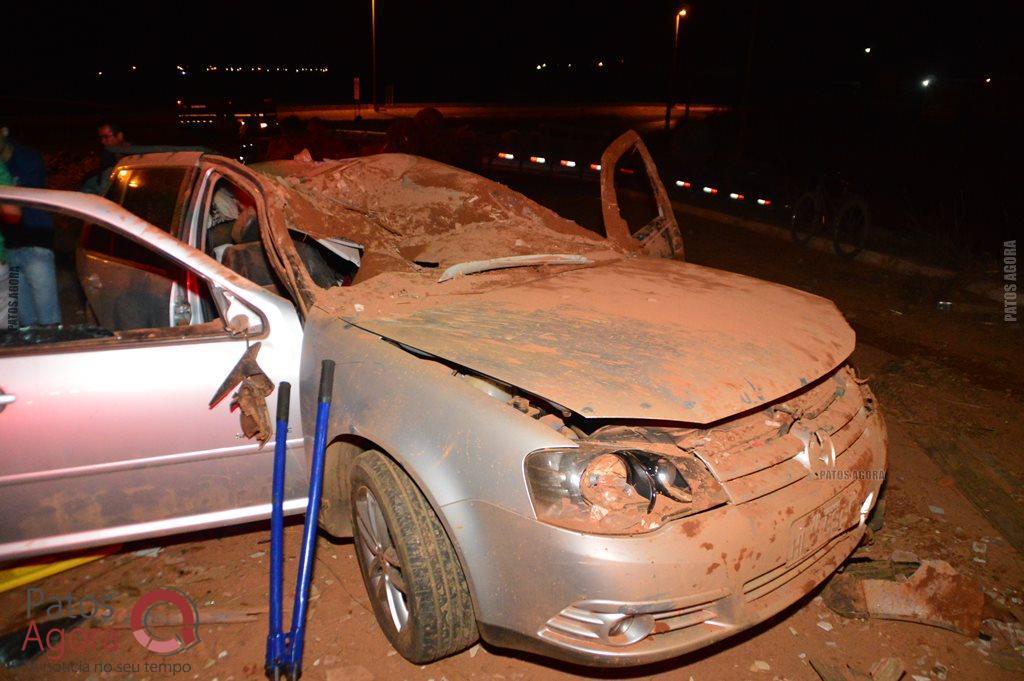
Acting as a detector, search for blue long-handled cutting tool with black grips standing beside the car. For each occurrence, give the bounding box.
[264,359,334,681]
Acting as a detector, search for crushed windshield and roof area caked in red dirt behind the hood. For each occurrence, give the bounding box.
[256,154,616,288]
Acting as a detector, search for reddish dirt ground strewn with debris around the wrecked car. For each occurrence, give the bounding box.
[0,197,1024,681]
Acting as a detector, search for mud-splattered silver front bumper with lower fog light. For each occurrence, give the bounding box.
[443,413,887,667]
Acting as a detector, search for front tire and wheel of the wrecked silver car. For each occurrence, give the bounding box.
[349,451,479,665]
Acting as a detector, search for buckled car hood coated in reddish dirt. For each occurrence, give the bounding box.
[342,258,854,424]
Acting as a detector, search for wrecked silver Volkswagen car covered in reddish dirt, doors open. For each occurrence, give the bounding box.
[0,135,887,666]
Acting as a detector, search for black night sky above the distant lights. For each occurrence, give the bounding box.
[3,0,1022,100]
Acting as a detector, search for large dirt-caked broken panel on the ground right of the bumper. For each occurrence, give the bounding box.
[822,560,985,637]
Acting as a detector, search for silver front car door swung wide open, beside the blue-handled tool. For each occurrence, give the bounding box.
[0,187,306,560]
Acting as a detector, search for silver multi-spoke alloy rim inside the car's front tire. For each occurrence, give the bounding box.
[355,487,409,632]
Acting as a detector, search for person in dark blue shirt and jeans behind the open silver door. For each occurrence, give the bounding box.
[0,126,60,327]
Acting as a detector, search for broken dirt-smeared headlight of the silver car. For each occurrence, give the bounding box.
[525,444,726,535]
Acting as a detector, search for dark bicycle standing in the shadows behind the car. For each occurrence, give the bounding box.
[790,176,871,258]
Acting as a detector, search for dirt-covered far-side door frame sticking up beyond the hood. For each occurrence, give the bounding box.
[601,130,686,260]
